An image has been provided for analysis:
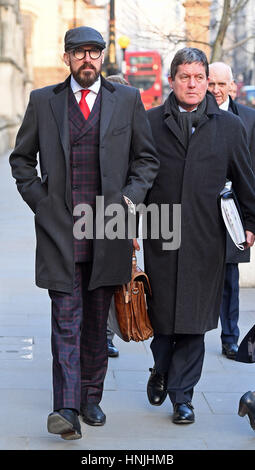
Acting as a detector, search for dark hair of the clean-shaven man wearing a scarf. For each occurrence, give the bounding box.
[170,47,209,80]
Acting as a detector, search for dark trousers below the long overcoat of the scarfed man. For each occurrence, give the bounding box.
[151,335,205,404]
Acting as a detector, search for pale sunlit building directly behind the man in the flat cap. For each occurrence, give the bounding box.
[20,0,108,88]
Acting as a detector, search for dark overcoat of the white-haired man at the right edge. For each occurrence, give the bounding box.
[226,97,255,263]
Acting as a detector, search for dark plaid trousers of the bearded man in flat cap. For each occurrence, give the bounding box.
[49,262,114,412]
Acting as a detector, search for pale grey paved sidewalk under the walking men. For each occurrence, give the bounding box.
[0,151,255,451]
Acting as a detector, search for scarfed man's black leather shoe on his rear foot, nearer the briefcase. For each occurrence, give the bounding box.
[147,367,167,406]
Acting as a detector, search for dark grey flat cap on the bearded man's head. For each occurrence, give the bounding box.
[65,26,106,51]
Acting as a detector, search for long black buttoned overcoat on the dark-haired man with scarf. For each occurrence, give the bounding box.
[144,93,255,334]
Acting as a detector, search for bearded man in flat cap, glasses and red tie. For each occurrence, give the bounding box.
[10,27,159,439]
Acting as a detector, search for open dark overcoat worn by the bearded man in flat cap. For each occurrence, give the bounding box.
[10,77,159,293]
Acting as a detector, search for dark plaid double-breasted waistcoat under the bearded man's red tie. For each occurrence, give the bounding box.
[68,89,101,263]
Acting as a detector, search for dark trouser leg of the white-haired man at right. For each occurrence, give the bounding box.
[220,263,240,344]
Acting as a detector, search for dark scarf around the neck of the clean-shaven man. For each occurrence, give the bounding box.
[169,93,206,149]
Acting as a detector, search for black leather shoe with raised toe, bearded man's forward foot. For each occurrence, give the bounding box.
[47,408,82,440]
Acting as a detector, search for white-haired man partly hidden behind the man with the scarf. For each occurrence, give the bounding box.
[208,62,255,359]
